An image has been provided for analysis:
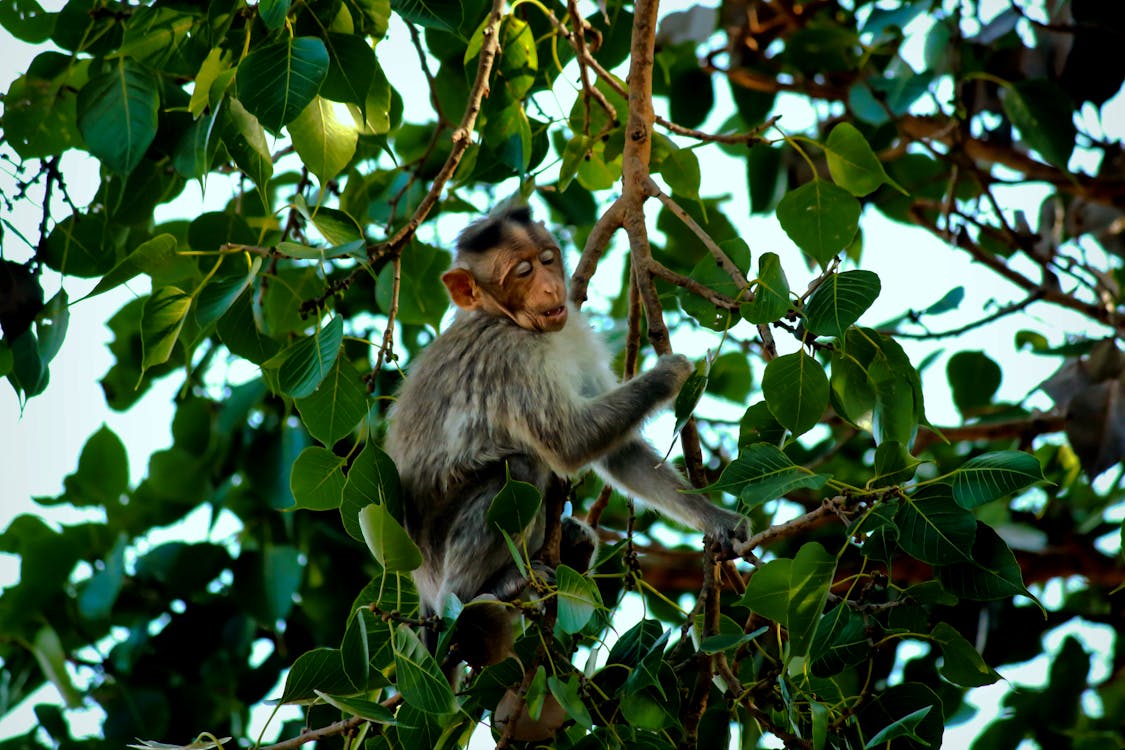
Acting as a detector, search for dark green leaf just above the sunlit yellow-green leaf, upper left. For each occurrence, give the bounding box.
[235,36,329,133]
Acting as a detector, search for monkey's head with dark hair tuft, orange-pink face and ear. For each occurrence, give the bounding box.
[441,206,567,333]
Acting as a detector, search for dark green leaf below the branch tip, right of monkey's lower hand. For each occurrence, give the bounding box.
[894,485,977,564]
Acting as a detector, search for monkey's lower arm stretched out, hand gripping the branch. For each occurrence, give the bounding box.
[596,437,749,542]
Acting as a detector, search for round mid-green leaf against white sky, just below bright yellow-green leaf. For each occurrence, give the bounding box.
[777,180,860,266]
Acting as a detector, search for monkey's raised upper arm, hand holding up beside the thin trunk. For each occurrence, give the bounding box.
[506,354,692,475]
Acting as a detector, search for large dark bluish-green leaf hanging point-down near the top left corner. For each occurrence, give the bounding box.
[78,57,160,174]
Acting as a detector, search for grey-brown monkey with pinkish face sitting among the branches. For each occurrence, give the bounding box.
[385,206,746,667]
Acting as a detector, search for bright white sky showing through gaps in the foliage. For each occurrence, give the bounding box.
[0,2,1125,747]
